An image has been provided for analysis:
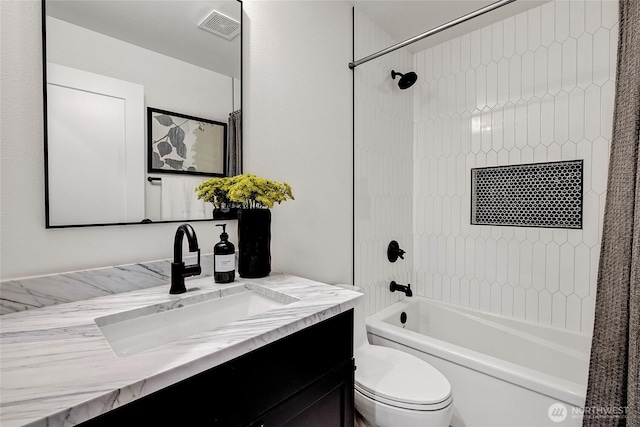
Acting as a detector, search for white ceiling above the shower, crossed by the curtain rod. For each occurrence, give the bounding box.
[351,0,550,59]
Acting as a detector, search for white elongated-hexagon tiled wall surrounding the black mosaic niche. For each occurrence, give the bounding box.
[412,0,618,332]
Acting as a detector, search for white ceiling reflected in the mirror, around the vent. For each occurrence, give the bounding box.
[46,0,241,78]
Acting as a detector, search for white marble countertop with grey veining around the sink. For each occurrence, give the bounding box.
[0,274,361,427]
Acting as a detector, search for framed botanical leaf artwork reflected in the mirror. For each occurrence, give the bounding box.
[147,107,227,176]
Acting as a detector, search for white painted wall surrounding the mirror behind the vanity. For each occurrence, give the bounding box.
[0,0,352,288]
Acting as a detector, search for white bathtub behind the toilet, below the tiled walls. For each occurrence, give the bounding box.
[366,297,591,427]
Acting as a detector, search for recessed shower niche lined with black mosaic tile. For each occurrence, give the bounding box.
[471,160,584,229]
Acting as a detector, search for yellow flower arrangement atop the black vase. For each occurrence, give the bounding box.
[195,174,295,209]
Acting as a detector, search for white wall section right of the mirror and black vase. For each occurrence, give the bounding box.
[243,1,352,283]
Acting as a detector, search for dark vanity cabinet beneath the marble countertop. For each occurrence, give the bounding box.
[82,310,354,427]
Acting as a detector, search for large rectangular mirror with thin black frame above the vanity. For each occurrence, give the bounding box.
[42,0,242,228]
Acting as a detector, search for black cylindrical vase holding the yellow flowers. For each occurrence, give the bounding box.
[238,209,271,279]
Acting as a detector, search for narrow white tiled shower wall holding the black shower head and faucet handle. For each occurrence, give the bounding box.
[354,10,413,315]
